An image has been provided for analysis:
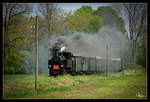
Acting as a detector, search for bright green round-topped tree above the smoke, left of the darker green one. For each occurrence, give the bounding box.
[65,6,103,32]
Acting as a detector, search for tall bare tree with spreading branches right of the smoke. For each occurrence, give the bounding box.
[113,3,146,71]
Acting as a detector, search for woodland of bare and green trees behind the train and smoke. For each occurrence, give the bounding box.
[2,3,147,74]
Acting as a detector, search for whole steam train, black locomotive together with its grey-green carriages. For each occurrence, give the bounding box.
[48,43,122,76]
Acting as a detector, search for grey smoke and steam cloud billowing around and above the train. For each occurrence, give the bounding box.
[23,26,126,74]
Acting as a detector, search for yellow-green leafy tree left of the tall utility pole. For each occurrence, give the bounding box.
[4,14,34,73]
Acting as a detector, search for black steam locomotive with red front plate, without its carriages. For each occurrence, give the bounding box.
[48,44,72,76]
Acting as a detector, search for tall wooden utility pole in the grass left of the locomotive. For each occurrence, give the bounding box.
[35,16,38,89]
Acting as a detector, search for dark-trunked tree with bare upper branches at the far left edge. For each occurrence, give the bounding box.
[3,3,30,73]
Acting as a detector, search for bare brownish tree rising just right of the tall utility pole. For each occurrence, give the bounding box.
[38,3,62,35]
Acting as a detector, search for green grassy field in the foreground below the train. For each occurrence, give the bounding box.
[3,68,147,99]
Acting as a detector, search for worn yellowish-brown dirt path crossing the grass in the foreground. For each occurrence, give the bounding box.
[29,82,100,99]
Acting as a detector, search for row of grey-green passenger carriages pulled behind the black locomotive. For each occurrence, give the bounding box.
[71,55,121,74]
